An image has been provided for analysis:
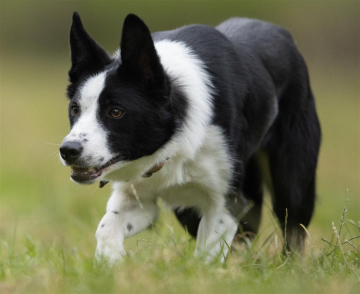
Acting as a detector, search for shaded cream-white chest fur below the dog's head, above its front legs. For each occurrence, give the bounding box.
[114,126,232,214]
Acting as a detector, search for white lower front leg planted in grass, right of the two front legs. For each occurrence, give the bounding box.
[195,210,238,262]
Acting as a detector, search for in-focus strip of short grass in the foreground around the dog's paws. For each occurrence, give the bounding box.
[0,198,360,293]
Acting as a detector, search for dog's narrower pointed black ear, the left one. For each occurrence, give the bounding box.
[69,12,111,83]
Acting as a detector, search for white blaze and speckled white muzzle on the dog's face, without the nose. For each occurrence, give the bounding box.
[60,72,114,167]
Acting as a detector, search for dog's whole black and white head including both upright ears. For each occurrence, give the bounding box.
[60,13,176,184]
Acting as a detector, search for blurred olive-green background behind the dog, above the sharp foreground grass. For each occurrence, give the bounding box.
[0,0,360,274]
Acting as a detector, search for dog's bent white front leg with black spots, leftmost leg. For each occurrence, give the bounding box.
[95,192,158,264]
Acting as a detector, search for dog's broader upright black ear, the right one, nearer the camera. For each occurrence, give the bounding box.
[119,14,164,87]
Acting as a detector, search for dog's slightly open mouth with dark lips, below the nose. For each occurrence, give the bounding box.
[71,156,123,184]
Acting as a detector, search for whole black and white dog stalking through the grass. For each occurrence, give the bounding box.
[60,13,321,262]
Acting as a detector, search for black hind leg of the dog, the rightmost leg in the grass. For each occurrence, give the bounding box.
[264,87,321,252]
